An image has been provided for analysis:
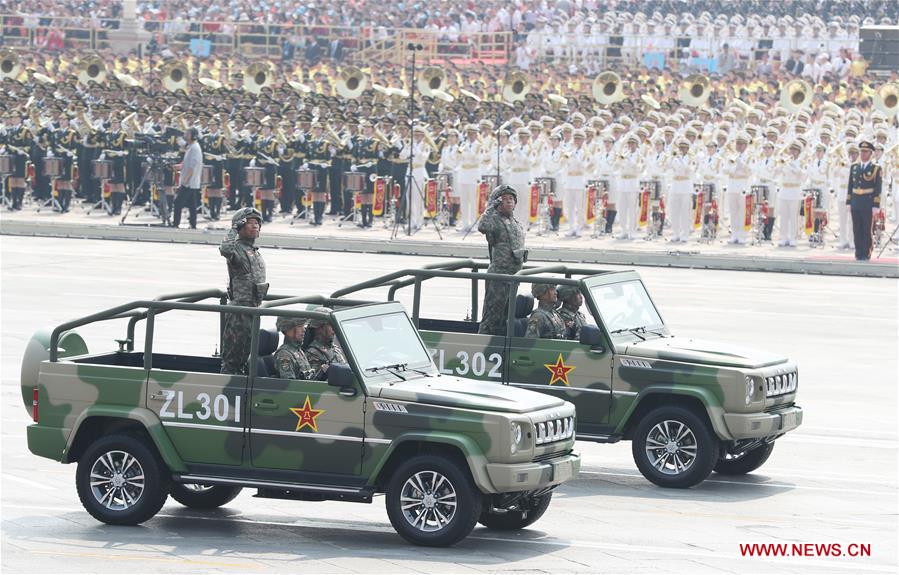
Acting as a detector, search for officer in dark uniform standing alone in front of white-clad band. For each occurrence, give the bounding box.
[846,142,883,261]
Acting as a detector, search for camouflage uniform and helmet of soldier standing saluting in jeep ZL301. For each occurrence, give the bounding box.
[219,208,268,375]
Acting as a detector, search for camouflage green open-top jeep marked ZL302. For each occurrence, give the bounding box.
[332,260,802,487]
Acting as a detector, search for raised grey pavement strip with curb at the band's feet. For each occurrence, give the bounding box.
[0,199,899,277]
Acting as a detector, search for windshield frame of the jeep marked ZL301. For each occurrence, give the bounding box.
[333,302,437,385]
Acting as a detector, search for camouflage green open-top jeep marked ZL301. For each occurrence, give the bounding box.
[21,290,580,546]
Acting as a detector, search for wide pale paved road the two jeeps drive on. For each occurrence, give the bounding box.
[0,236,899,574]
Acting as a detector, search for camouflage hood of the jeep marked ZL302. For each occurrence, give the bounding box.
[625,337,789,369]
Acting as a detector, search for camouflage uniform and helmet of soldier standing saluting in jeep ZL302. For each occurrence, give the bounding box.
[478,187,527,335]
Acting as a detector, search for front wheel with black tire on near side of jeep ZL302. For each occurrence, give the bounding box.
[631,406,718,489]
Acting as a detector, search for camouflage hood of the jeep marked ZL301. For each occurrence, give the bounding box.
[378,375,565,413]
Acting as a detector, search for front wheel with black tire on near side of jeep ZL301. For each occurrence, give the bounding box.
[385,455,482,547]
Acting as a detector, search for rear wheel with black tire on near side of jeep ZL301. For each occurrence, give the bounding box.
[75,435,169,525]
